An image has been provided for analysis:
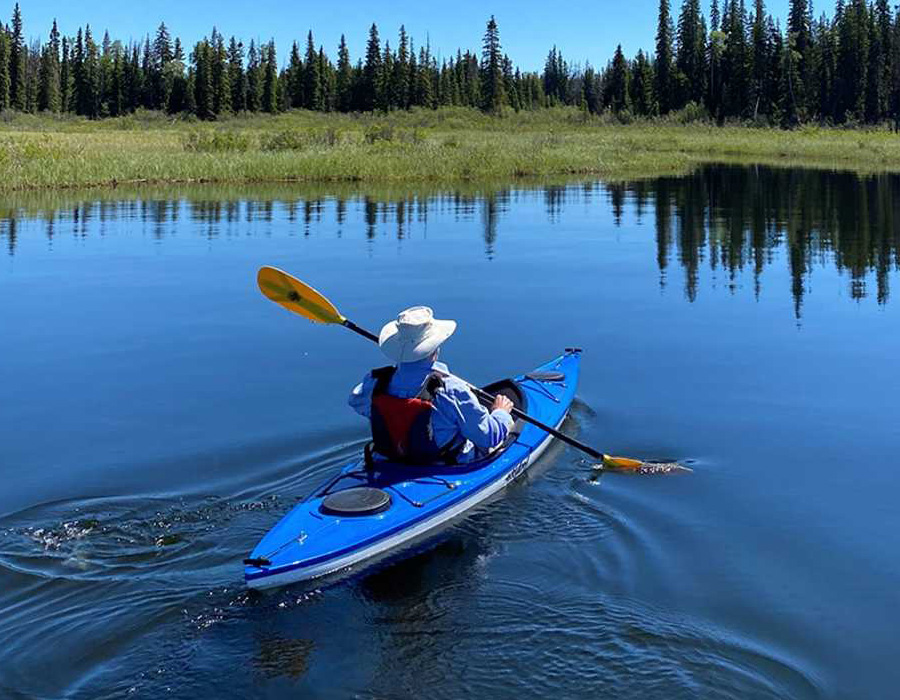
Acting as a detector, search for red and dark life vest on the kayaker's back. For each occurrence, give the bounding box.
[369,367,465,464]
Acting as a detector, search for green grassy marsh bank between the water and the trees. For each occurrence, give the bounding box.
[0,108,900,192]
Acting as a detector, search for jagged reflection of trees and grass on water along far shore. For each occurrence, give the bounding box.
[0,166,900,317]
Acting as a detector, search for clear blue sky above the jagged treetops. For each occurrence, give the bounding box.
[19,0,796,69]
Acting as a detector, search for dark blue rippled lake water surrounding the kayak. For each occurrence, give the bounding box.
[0,167,900,700]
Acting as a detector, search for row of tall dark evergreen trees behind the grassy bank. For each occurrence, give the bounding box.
[0,0,900,126]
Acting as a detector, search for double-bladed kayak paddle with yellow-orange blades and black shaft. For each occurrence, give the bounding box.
[257,266,647,471]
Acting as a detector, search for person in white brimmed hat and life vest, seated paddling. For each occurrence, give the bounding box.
[349,306,513,464]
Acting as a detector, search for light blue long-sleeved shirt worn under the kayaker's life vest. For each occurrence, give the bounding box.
[349,358,514,462]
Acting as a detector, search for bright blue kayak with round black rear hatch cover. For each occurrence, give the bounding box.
[244,349,581,588]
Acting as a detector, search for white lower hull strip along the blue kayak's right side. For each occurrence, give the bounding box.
[246,411,569,589]
